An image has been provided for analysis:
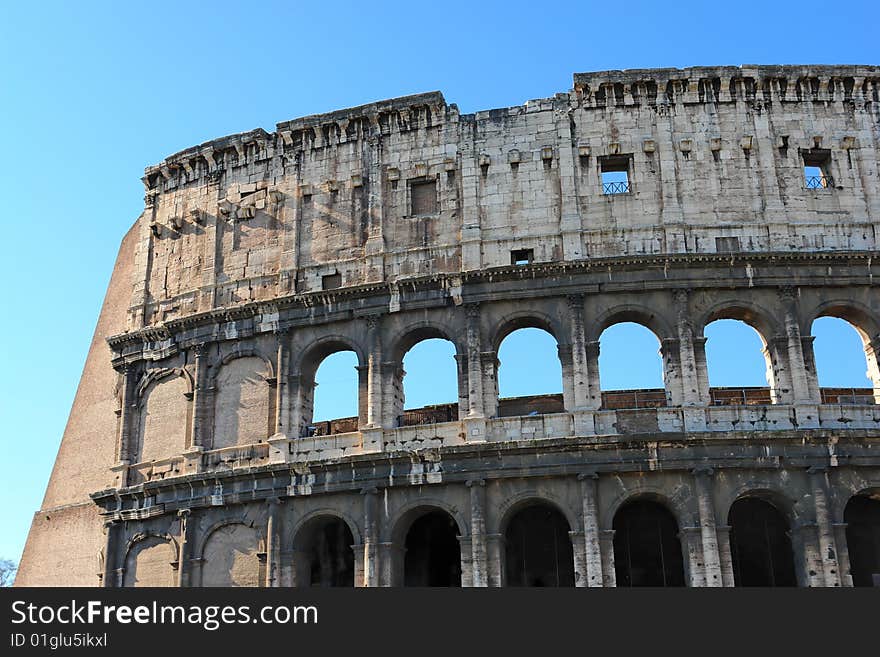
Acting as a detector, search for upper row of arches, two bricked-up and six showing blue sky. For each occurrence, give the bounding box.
[131,304,880,462]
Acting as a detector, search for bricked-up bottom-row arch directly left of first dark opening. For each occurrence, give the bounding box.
[198,520,266,587]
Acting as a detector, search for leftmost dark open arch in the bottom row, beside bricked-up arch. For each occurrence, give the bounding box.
[305,518,354,586]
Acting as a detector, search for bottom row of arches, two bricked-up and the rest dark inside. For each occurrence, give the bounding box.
[123,491,880,587]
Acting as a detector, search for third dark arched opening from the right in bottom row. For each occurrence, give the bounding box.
[613,500,684,586]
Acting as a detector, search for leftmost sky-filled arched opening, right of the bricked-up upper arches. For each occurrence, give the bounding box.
[304,349,359,436]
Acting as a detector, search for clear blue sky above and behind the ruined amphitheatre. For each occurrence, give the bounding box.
[0,0,880,559]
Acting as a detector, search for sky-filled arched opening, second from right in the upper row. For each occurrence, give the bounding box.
[703,319,773,406]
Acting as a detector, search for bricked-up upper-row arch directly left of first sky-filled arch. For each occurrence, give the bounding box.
[212,349,275,449]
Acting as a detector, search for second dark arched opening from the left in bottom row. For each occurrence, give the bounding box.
[403,509,461,586]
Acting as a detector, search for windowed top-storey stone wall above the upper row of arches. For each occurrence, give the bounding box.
[129,66,880,330]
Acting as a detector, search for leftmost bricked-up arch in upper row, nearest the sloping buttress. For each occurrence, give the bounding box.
[132,368,193,462]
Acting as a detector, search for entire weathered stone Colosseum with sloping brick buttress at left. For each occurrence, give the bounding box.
[17,66,880,587]
